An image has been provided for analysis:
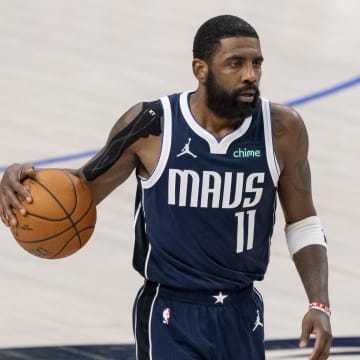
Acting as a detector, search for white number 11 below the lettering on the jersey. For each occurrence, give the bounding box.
[235,210,256,253]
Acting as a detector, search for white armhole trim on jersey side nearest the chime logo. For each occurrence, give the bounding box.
[261,98,280,187]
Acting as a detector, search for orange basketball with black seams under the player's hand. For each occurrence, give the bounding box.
[11,169,96,259]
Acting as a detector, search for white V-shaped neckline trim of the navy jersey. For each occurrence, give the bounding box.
[180,91,252,155]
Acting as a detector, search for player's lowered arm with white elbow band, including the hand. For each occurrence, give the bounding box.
[273,105,332,360]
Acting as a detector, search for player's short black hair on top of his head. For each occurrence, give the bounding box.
[193,15,259,62]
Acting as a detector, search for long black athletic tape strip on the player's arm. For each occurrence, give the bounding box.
[83,100,162,181]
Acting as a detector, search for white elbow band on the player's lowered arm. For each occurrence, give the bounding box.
[285,216,327,257]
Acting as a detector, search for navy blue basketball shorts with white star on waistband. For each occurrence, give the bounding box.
[133,281,265,360]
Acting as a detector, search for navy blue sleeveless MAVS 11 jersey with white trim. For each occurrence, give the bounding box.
[133,92,279,289]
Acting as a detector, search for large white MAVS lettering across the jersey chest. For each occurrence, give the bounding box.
[168,169,265,209]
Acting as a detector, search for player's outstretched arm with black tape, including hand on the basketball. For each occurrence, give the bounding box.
[0,101,162,226]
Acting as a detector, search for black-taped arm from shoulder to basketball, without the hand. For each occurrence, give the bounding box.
[76,101,162,204]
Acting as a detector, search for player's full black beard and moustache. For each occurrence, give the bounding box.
[205,69,260,119]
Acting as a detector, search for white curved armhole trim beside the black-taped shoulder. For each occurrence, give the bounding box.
[140,96,172,189]
